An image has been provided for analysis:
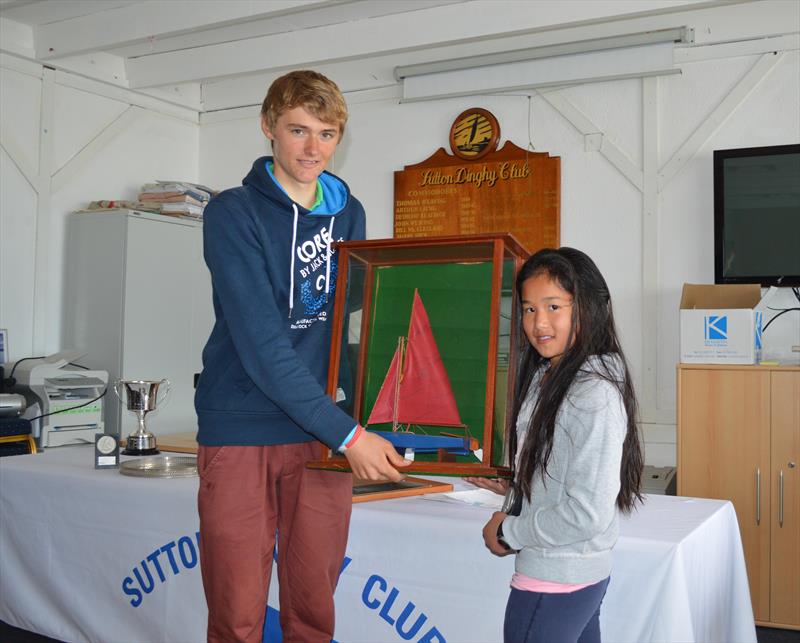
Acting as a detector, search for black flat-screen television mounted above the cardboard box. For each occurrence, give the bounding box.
[714,144,800,286]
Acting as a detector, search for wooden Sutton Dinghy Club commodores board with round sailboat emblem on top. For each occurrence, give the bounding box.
[394,107,561,252]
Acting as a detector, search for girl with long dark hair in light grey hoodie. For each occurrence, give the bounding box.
[471,248,643,643]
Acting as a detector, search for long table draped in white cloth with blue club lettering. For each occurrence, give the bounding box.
[0,446,756,643]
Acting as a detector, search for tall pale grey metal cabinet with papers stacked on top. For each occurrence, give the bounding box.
[62,210,214,437]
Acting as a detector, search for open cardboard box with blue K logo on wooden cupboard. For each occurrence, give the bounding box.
[680,284,761,364]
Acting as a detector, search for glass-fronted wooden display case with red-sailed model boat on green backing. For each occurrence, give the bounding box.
[310,234,528,476]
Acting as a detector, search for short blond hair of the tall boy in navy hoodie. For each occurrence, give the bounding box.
[261,69,347,136]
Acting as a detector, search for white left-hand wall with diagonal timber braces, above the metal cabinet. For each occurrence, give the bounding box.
[0,55,199,360]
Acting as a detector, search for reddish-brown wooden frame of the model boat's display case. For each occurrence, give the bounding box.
[309,233,528,477]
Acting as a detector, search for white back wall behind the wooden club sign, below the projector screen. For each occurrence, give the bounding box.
[200,49,800,466]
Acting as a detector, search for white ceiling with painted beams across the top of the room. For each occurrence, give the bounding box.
[0,0,780,109]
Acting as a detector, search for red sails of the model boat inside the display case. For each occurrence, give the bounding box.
[367,291,462,426]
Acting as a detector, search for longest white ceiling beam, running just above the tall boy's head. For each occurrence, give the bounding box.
[127,0,720,87]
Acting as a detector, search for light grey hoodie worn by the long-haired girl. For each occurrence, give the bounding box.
[503,355,627,583]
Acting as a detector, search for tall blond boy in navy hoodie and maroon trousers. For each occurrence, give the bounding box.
[195,71,405,643]
